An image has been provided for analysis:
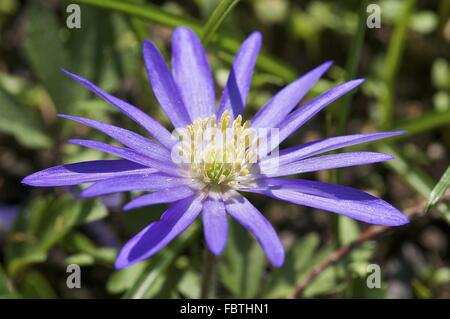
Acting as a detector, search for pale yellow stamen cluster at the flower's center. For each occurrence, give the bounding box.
[178,110,257,187]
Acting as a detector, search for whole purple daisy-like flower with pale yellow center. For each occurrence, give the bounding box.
[23,27,408,268]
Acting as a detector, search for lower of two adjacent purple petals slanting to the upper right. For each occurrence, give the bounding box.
[279,79,364,143]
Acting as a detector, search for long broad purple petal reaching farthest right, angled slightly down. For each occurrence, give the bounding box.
[244,178,408,226]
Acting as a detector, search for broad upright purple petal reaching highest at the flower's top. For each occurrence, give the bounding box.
[172,27,216,120]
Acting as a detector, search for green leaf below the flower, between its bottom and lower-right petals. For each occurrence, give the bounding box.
[218,219,266,298]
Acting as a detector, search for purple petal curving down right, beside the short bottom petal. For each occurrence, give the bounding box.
[225,191,284,267]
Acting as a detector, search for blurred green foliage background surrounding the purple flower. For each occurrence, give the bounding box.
[0,0,450,298]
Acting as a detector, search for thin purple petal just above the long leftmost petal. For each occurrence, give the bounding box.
[68,139,177,175]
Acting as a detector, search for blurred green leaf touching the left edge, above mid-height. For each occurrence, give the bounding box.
[0,87,52,148]
